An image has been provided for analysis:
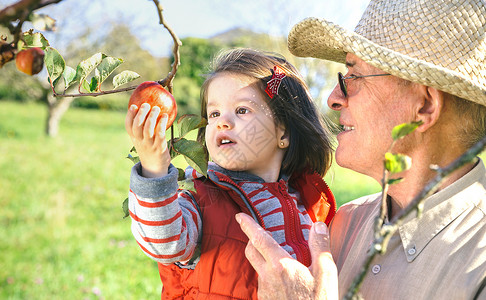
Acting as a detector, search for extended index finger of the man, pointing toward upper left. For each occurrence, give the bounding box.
[236,213,290,261]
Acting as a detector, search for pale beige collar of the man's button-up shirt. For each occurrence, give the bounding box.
[398,159,486,262]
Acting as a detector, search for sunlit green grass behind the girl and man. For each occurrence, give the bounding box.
[9,101,480,300]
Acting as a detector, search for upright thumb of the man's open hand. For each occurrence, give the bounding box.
[309,222,339,299]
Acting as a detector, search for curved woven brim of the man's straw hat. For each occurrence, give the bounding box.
[288,18,486,105]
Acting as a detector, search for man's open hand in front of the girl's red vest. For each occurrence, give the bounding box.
[236,213,338,300]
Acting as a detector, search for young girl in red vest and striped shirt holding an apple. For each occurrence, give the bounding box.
[126,49,336,299]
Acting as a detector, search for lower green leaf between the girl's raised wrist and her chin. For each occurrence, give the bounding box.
[172,138,208,176]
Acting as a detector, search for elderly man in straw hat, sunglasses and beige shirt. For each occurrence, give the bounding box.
[237,0,486,299]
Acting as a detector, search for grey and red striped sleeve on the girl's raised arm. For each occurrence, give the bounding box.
[128,164,202,264]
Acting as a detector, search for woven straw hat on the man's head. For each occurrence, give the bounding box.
[288,0,486,105]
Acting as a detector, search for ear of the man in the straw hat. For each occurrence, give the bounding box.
[416,85,446,132]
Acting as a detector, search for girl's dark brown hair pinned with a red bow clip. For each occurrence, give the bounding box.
[198,49,333,176]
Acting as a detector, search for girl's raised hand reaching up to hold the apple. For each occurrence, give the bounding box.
[125,103,170,178]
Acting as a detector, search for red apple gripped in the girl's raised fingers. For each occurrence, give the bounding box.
[128,81,177,129]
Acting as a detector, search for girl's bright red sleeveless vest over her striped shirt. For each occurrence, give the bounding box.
[158,174,336,299]
